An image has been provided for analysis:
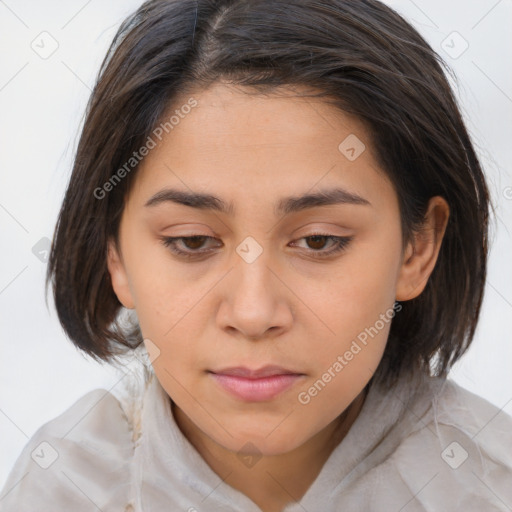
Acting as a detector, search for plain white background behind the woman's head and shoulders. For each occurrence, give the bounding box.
[0,0,512,487]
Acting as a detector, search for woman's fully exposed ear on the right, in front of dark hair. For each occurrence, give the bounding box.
[396,196,450,301]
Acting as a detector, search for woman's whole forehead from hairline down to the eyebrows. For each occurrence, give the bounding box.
[127,84,394,215]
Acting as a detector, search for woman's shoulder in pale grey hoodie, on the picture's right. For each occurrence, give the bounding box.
[385,380,512,511]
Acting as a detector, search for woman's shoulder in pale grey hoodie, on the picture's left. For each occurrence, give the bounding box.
[0,372,145,512]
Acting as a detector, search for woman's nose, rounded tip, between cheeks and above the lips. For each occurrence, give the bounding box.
[217,254,293,341]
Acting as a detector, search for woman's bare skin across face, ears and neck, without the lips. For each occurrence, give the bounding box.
[108,83,449,512]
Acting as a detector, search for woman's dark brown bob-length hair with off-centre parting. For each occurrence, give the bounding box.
[46,0,490,384]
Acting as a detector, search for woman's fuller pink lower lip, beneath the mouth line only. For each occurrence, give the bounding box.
[210,373,303,402]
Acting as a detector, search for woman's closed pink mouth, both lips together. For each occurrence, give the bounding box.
[208,366,305,402]
